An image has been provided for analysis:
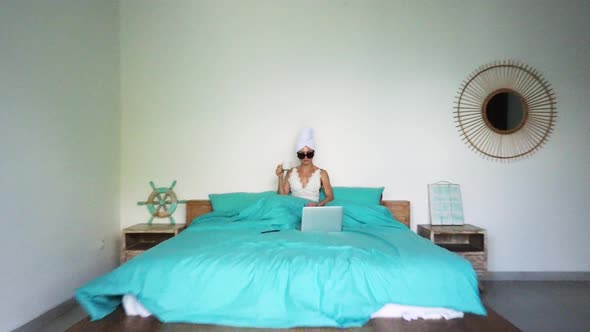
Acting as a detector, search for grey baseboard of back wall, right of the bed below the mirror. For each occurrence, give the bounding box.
[481,271,590,281]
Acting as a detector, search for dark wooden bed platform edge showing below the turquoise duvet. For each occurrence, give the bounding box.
[66,307,520,332]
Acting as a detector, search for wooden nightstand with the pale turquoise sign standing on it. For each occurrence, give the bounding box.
[418,224,488,277]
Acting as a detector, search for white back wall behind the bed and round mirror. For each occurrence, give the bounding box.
[120,0,590,271]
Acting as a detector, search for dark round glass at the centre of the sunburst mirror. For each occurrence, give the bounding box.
[486,92,525,131]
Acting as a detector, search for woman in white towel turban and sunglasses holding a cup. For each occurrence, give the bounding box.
[276,128,334,206]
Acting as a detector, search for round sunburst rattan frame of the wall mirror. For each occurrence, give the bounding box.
[454,60,557,160]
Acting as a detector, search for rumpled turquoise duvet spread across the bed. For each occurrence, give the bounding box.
[76,196,486,328]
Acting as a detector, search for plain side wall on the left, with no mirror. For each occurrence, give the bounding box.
[0,0,120,331]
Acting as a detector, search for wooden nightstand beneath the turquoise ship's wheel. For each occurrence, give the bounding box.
[121,224,185,264]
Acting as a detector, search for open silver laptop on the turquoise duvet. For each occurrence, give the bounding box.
[301,206,343,232]
